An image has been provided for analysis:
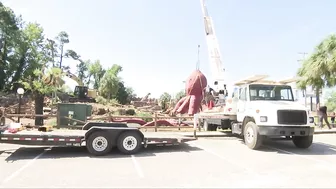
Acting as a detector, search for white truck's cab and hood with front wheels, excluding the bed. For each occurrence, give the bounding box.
[232,78,314,149]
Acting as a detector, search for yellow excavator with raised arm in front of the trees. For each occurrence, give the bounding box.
[66,71,98,102]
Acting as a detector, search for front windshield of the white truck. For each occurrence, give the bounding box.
[249,85,294,101]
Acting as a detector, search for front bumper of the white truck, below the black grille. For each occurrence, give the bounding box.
[259,126,314,136]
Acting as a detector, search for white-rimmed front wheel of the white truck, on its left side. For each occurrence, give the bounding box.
[244,121,263,150]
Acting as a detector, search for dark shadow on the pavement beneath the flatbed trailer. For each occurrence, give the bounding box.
[1,144,202,162]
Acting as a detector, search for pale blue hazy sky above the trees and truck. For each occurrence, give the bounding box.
[2,0,336,99]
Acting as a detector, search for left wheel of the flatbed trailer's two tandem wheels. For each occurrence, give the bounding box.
[86,131,112,156]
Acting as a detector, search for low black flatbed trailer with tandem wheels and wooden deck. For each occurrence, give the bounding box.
[0,122,196,156]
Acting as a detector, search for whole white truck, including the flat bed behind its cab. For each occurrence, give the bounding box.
[197,75,314,149]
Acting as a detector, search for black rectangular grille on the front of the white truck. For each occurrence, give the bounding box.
[278,110,307,125]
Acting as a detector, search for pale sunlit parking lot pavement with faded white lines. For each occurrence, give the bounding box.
[0,134,336,188]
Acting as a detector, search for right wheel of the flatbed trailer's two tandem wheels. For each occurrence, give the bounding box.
[117,132,142,154]
